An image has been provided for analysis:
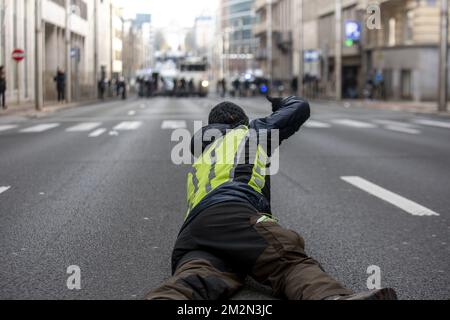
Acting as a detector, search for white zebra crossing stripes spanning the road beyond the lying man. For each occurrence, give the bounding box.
[0,119,450,138]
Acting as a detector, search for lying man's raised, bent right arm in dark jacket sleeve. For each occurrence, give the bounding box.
[251,96,311,144]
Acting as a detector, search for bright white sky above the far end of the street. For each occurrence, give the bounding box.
[115,0,218,28]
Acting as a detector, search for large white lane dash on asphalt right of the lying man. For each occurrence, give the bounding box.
[341,177,439,216]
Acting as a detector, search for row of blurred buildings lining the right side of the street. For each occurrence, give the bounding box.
[253,0,448,101]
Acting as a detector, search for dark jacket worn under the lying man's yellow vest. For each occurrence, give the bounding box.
[182,97,311,230]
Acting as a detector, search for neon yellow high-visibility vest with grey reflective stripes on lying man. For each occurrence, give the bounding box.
[186,127,269,218]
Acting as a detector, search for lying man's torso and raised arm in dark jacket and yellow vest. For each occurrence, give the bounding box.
[186,97,310,229]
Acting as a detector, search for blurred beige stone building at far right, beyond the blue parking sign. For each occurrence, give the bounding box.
[363,0,450,101]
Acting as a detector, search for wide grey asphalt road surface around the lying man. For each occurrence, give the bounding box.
[0,98,450,299]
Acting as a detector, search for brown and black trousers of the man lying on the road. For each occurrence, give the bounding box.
[146,204,352,300]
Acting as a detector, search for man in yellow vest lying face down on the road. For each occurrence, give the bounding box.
[146,97,396,300]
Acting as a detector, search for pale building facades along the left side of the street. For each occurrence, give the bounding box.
[0,0,122,103]
